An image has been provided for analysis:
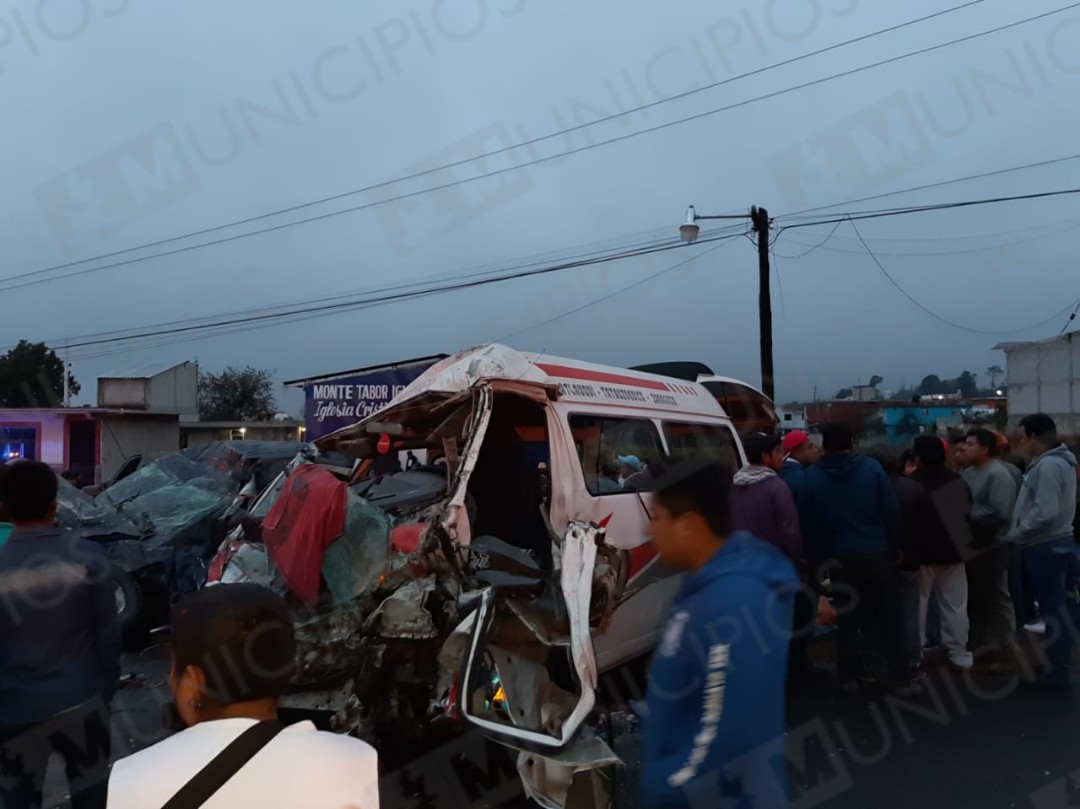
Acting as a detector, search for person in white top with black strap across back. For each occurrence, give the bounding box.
[108,583,379,809]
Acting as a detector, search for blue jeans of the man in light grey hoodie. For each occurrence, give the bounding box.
[1024,535,1076,683]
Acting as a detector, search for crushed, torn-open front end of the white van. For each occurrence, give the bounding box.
[210,385,617,807]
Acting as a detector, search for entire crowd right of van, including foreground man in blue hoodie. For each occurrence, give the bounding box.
[642,415,1080,807]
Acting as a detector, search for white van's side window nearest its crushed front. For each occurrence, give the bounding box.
[570,416,663,497]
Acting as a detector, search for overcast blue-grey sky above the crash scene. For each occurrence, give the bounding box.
[0,0,1080,409]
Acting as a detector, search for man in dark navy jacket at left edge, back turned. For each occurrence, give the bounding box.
[0,461,121,809]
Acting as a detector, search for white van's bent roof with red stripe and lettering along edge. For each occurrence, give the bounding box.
[391,343,727,418]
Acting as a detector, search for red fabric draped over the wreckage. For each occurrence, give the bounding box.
[262,463,347,602]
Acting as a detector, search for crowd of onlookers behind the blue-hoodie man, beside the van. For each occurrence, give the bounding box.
[731,415,1080,692]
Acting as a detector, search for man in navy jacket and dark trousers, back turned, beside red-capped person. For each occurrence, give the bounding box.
[800,424,910,692]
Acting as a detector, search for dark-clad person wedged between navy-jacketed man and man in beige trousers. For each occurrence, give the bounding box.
[867,446,927,677]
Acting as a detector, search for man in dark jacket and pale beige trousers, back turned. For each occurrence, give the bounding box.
[912,435,975,669]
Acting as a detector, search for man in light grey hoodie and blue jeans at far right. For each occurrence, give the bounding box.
[1007,413,1077,687]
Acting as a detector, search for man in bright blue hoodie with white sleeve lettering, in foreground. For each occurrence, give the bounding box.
[640,460,800,809]
